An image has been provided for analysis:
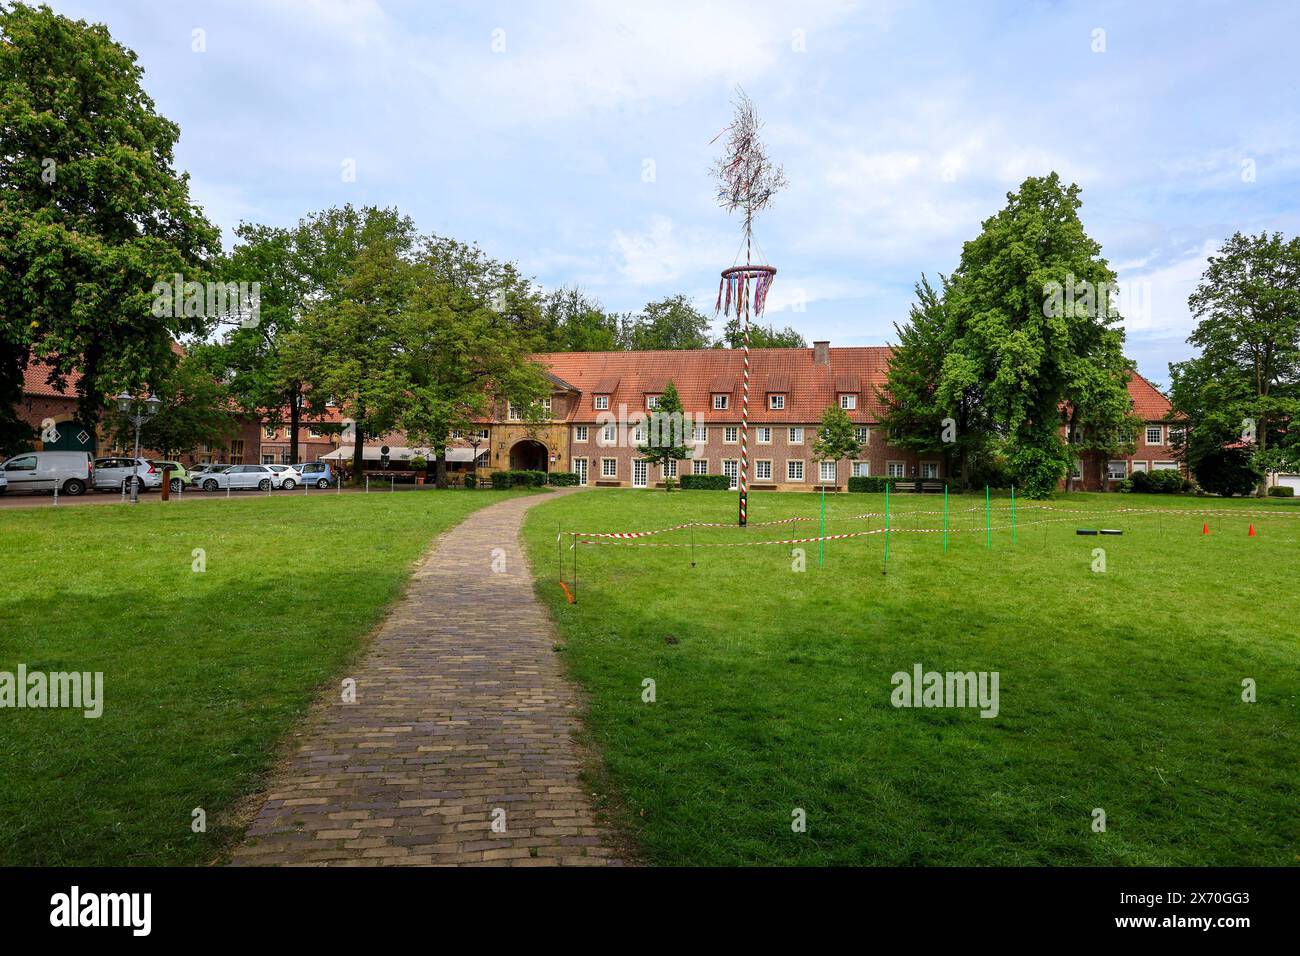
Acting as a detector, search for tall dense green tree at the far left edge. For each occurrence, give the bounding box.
[0,3,220,455]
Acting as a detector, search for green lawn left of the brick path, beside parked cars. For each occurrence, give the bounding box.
[0,490,533,865]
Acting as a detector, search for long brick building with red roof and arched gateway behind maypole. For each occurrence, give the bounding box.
[470,342,1179,490]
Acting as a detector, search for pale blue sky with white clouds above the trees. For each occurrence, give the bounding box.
[51,0,1300,385]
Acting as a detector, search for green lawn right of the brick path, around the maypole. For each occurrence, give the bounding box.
[525,490,1300,865]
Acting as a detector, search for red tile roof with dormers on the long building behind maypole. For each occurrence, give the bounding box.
[537,346,1170,424]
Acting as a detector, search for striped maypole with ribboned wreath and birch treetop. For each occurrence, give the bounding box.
[714,90,785,527]
